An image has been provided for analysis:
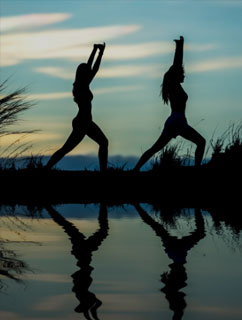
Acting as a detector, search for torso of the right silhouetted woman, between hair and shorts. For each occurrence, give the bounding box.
[169,84,188,113]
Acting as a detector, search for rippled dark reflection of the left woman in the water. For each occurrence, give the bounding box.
[47,204,108,320]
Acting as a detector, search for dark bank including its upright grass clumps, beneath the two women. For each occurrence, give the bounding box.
[0,124,242,206]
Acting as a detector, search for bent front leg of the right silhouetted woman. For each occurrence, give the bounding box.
[181,126,206,167]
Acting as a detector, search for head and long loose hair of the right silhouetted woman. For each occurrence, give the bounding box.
[161,65,185,104]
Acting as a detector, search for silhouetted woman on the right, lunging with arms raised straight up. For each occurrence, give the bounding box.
[134,37,205,170]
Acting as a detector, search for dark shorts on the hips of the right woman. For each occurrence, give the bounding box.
[162,112,190,138]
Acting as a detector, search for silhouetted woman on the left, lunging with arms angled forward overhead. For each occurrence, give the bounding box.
[46,43,108,170]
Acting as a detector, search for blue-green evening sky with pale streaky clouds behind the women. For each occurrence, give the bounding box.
[0,0,242,156]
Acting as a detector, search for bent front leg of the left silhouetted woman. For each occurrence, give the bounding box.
[87,121,108,171]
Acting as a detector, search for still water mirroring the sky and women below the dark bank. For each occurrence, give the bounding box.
[0,203,242,320]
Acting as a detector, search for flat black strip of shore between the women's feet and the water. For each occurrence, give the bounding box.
[0,167,241,207]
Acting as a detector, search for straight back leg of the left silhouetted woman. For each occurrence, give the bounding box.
[46,130,85,169]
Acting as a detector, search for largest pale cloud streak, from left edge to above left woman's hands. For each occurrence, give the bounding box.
[0,25,141,66]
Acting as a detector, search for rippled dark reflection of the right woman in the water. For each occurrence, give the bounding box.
[135,204,205,320]
